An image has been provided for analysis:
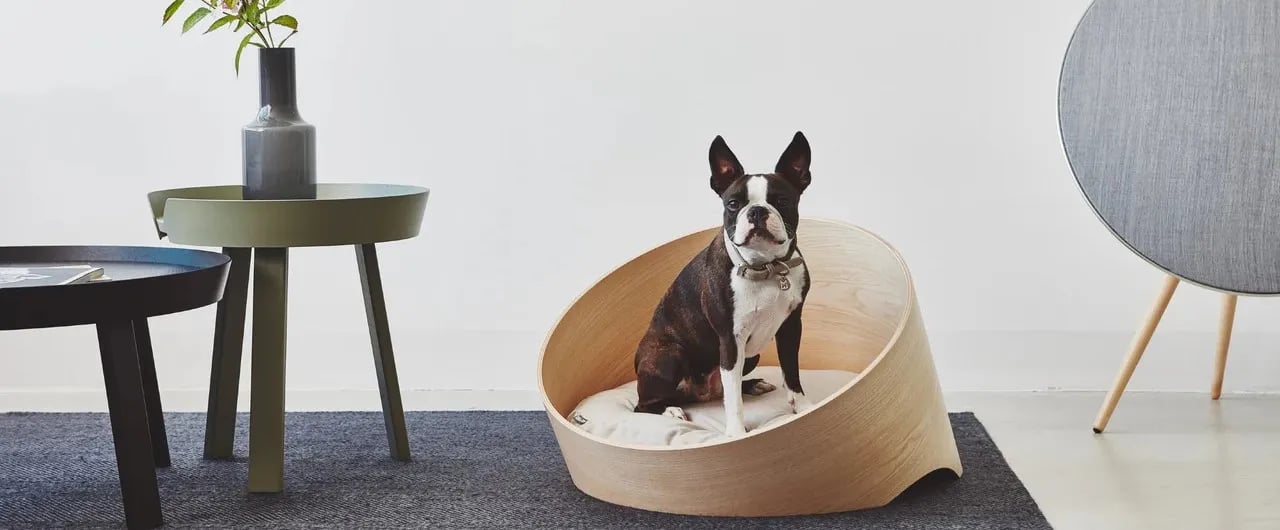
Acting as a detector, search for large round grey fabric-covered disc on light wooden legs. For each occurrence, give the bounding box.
[1059,0,1280,294]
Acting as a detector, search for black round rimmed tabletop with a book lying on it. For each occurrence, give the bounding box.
[0,246,230,329]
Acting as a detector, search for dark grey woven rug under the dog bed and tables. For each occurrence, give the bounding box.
[0,412,1050,530]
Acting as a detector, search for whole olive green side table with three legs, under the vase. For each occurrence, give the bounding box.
[148,184,429,493]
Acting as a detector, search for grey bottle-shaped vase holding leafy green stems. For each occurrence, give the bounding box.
[242,47,316,198]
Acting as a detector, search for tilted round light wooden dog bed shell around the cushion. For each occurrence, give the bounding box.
[539,219,961,516]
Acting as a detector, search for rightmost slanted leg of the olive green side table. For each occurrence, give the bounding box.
[356,243,410,462]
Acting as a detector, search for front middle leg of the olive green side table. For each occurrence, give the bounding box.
[248,248,289,493]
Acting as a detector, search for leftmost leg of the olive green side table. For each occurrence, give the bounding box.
[205,247,253,460]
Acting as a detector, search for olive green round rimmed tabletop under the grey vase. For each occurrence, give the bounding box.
[147,183,429,248]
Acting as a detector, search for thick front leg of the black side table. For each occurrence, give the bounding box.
[97,320,164,529]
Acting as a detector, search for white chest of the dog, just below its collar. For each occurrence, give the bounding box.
[730,265,805,357]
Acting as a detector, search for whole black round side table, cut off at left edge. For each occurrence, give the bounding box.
[0,246,230,529]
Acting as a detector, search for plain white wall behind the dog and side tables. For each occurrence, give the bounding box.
[0,0,1280,410]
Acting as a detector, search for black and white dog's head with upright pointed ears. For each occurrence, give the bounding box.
[709,132,810,264]
